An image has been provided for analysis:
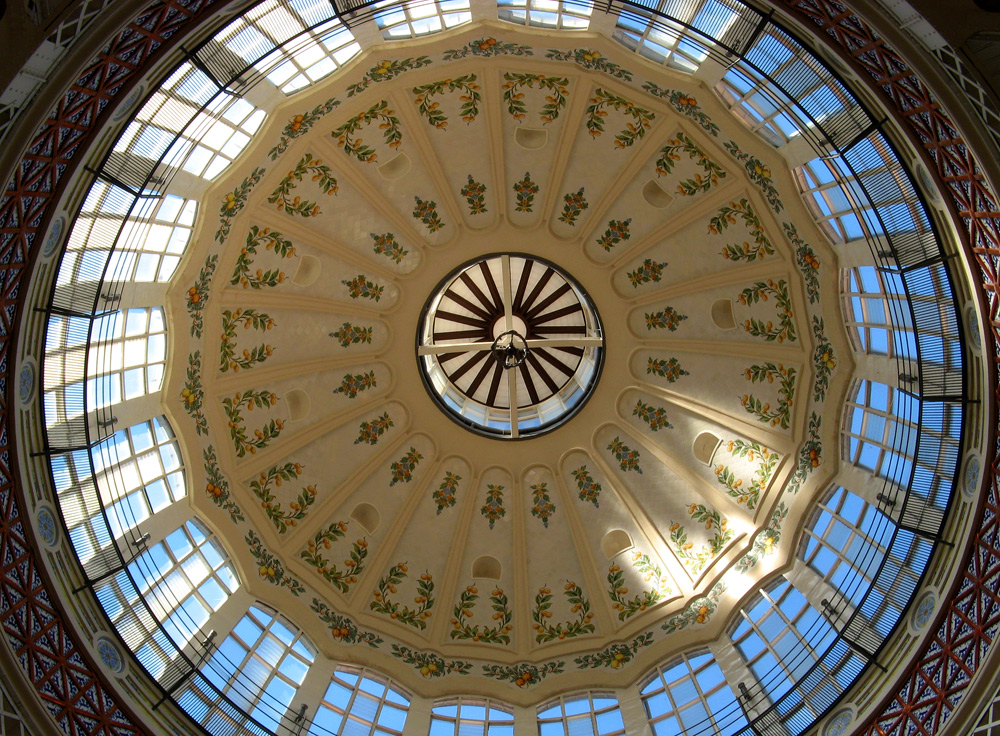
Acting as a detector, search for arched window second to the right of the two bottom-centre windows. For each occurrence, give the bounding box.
[730,578,864,723]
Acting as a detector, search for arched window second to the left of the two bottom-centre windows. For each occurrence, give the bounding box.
[187,605,316,734]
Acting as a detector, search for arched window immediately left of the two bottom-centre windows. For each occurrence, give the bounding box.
[309,666,410,736]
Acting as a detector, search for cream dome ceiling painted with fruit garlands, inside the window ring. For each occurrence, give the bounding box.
[170,25,852,703]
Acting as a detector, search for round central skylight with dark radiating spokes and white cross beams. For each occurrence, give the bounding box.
[417,254,604,439]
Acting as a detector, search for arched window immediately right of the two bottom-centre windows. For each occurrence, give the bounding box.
[640,650,747,736]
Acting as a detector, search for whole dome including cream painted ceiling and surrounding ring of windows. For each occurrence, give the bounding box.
[0,0,989,734]
